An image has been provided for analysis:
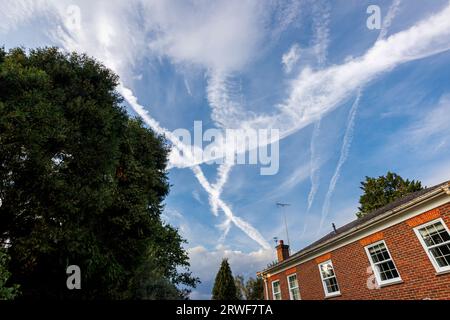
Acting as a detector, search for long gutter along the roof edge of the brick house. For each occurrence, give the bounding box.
[257,182,450,277]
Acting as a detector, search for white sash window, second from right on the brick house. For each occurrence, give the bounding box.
[365,240,402,285]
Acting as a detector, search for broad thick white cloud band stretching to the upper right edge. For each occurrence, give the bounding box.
[243,5,450,137]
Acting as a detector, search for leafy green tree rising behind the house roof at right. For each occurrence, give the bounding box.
[356,171,423,218]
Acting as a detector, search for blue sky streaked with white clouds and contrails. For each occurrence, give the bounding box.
[0,0,450,299]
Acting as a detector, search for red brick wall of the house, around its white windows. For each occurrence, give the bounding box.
[268,202,450,300]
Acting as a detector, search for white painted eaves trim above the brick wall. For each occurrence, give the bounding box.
[262,190,450,277]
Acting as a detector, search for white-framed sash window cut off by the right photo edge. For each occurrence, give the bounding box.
[414,219,450,272]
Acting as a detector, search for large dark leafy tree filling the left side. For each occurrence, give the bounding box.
[0,48,197,299]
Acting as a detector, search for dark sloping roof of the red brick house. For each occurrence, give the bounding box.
[263,180,450,272]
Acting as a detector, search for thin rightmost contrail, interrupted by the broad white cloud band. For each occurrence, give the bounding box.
[317,0,401,234]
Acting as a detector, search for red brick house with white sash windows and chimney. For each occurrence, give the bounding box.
[258,181,450,300]
